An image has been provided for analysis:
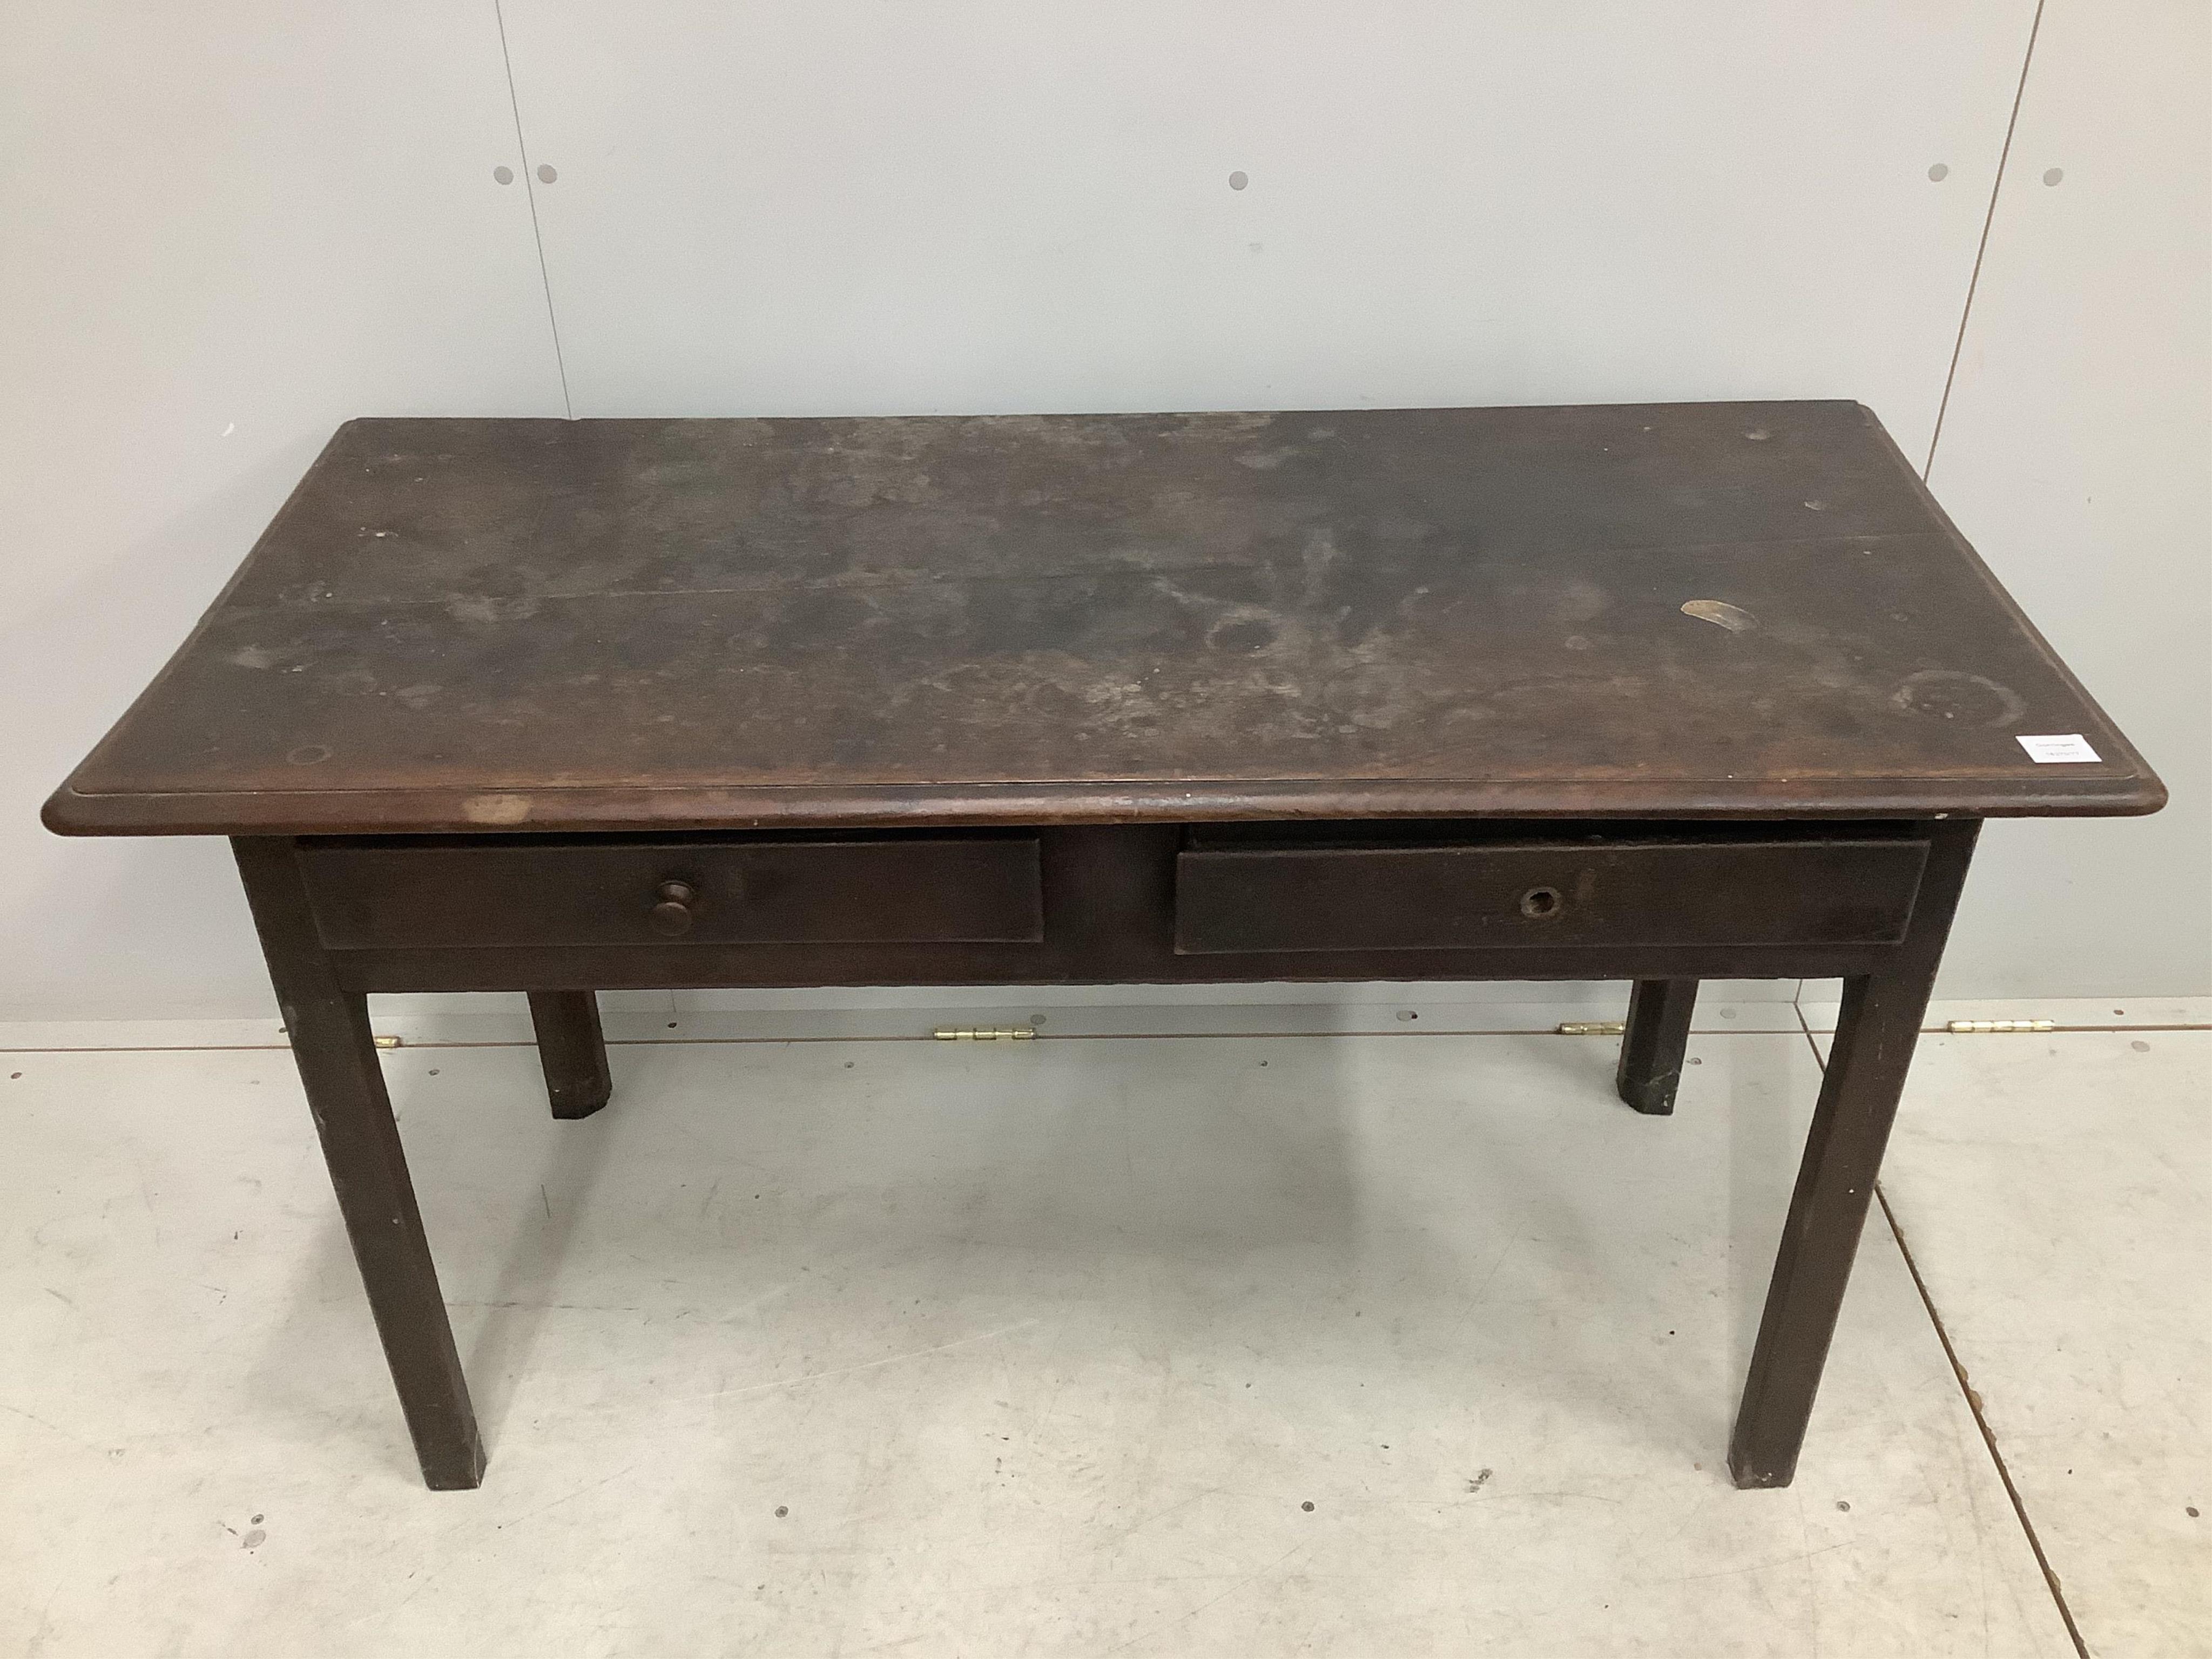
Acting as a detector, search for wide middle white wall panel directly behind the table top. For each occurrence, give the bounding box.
[507,0,2033,454]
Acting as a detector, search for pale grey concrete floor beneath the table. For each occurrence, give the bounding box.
[0,1031,2212,1659]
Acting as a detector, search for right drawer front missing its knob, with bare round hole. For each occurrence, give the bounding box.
[1175,840,1927,953]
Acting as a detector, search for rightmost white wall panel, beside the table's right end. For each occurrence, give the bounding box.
[1929,0,2212,995]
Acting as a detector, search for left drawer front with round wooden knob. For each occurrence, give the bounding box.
[301,834,1044,949]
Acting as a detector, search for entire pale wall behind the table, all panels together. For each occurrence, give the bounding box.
[0,0,2212,1017]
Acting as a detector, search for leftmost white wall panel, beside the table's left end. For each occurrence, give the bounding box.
[0,0,562,1017]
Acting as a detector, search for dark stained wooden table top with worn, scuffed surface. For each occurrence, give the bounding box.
[46,402,2166,834]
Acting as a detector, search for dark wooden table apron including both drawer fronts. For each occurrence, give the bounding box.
[296,823,1951,993]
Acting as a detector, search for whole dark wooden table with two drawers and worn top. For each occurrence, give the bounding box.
[46,402,2163,1487]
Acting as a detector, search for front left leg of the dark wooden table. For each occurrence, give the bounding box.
[232,838,484,1491]
